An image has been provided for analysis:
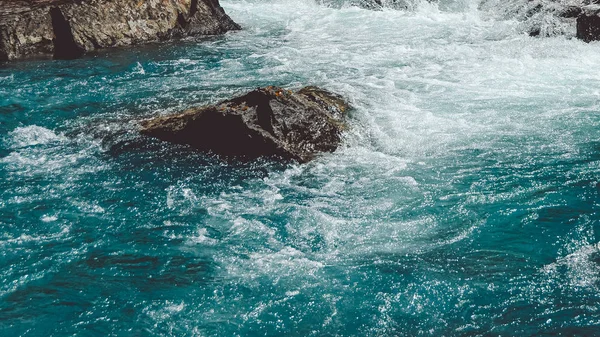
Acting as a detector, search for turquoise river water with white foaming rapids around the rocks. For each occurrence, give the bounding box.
[0,0,600,336]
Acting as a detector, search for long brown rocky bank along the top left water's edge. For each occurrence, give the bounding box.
[0,0,240,60]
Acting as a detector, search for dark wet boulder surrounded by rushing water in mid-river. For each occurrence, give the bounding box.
[141,87,349,162]
